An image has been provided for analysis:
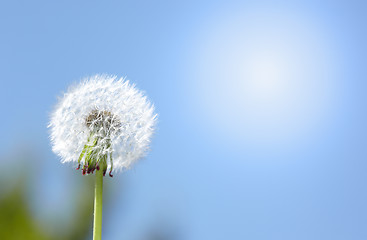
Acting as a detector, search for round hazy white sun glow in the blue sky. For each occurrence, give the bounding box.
[191,7,340,147]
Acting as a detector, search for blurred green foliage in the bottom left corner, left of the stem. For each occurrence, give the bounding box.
[0,172,93,240]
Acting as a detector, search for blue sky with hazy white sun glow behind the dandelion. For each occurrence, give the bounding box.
[0,1,367,240]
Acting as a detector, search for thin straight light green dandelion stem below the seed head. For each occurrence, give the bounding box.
[93,166,103,240]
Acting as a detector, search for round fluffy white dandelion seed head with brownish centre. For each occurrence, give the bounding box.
[49,75,157,174]
